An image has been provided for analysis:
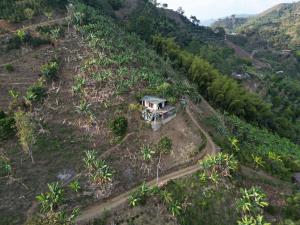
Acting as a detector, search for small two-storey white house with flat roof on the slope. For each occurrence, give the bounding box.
[141,95,176,130]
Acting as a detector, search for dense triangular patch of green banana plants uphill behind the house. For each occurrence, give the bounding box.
[71,1,199,103]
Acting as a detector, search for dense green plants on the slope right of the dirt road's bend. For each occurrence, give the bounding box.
[225,116,300,180]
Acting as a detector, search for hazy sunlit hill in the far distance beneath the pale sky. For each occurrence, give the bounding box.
[214,2,300,49]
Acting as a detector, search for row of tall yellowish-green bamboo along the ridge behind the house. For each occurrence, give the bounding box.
[153,36,271,123]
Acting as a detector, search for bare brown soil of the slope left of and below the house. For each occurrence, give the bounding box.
[0,16,203,224]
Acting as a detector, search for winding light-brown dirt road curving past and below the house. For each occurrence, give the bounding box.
[76,105,217,224]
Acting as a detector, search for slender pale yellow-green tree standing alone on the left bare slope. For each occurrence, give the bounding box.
[15,111,36,163]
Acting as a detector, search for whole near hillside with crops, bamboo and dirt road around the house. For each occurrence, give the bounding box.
[0,0,300,225]
